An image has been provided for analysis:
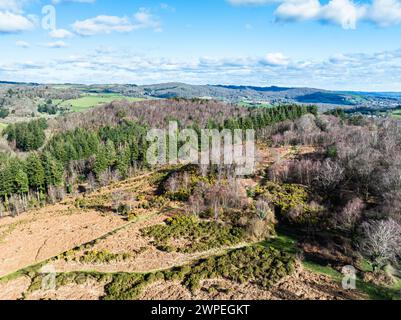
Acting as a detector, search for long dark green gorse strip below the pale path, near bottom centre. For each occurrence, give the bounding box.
[100,246,294,300]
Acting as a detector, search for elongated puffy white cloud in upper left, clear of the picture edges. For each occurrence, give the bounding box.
[72,8,161,36]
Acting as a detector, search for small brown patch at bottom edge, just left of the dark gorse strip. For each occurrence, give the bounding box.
[25,280,104,301]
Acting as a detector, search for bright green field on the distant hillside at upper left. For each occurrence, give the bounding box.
[59,94,144,112]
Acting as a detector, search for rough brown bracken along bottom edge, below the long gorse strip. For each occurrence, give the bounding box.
[140,268,363,300]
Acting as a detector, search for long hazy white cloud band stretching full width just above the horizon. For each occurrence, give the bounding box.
[0,43,401,91]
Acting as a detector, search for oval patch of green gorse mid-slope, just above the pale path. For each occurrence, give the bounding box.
[142,216,245,253]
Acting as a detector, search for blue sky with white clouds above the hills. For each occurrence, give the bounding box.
[0,0,401,91]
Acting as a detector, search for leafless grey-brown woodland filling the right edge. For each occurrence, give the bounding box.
[264,115,401,267]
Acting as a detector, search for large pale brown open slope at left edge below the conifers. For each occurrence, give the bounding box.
[0,204,126,276]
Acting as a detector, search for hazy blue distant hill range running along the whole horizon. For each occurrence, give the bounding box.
[0,81,401,110]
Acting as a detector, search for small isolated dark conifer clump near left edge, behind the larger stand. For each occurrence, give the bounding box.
[3,119,47,152]
